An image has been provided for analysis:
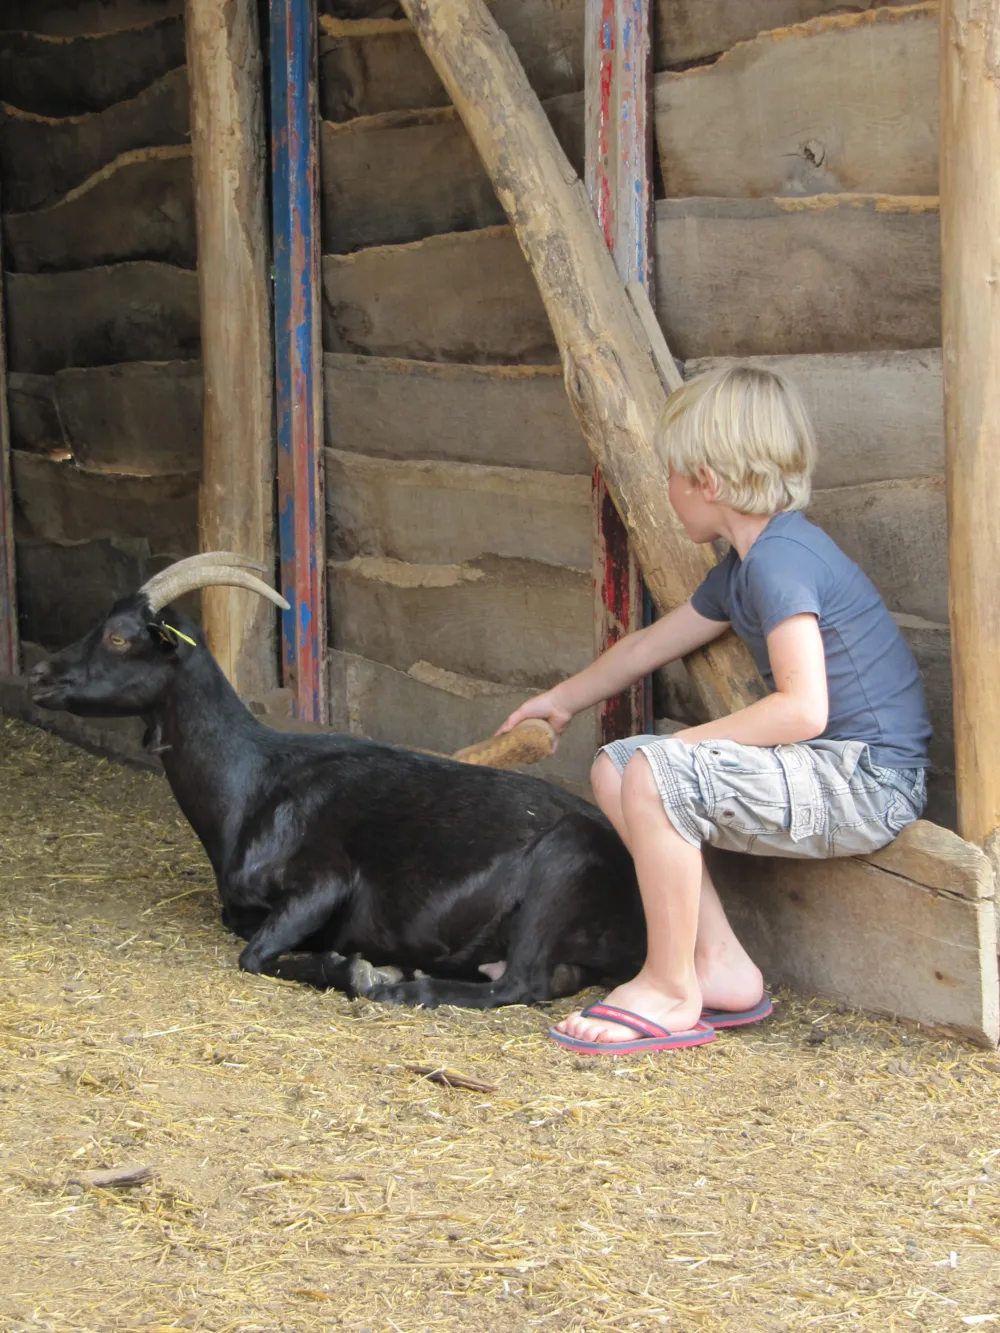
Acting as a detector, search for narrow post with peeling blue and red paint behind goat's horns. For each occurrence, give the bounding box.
[271,0,328,722]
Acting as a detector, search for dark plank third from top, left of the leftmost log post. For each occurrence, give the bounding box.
[0,67,189,213]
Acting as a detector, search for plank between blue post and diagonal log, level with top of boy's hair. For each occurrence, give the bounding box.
[323,352,591,476]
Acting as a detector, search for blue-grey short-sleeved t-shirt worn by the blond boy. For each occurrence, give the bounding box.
[691,513,931,768]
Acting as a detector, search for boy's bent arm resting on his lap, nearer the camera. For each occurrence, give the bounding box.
[675,613,829,746]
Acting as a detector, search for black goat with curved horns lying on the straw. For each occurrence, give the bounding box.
[32,553,645,1009]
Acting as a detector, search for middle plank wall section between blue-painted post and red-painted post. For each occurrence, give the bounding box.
[320,0,595,784]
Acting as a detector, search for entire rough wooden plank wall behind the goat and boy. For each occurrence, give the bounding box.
[0,0,953,822]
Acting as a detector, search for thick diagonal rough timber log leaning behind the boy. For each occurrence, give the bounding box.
[404,0,761,716]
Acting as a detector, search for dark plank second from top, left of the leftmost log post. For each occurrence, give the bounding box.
[0,15,184,116]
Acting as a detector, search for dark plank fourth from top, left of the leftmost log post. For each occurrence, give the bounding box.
[3,145,196,273]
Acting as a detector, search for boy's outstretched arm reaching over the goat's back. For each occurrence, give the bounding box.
[496,601,729,736]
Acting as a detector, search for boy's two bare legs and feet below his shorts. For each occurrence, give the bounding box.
[557,754,764,1041]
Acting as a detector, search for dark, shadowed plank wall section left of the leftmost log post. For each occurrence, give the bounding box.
[0,0,201,648]
